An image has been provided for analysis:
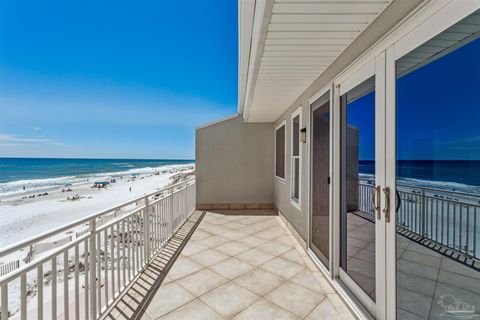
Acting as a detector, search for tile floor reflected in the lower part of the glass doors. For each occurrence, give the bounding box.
[347,214,480,320]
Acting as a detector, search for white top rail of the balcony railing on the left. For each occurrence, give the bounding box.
[0,178,195,258]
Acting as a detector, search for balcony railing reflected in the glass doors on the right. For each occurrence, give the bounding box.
[358,180,480,261]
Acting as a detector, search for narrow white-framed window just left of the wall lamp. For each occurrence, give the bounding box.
[290,109,301,204]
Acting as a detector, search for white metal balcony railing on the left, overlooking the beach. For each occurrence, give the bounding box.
[0,179,195,320]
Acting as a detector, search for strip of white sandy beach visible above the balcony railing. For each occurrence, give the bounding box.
[0,164,193,247]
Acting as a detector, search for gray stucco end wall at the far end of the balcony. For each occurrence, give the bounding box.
[195,116,274,204]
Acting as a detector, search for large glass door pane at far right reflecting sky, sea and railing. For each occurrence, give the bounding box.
[396,8,480,319]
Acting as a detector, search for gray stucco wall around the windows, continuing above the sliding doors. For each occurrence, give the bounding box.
[274,0,423,241]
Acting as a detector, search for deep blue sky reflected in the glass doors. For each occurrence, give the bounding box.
[348,39,480,160]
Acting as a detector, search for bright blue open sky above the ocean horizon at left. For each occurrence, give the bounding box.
[0,0,238,159]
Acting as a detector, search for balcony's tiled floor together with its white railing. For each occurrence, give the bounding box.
[0,180,354,320]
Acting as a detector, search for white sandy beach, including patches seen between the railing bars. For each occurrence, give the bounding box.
[0,164,194,319]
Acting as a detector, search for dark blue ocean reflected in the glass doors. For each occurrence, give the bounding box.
[359,160,480,195]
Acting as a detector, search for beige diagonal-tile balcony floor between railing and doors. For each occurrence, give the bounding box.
[142,212,354,320]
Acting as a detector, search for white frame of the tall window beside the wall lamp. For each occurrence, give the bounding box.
[290,106,302,210]
